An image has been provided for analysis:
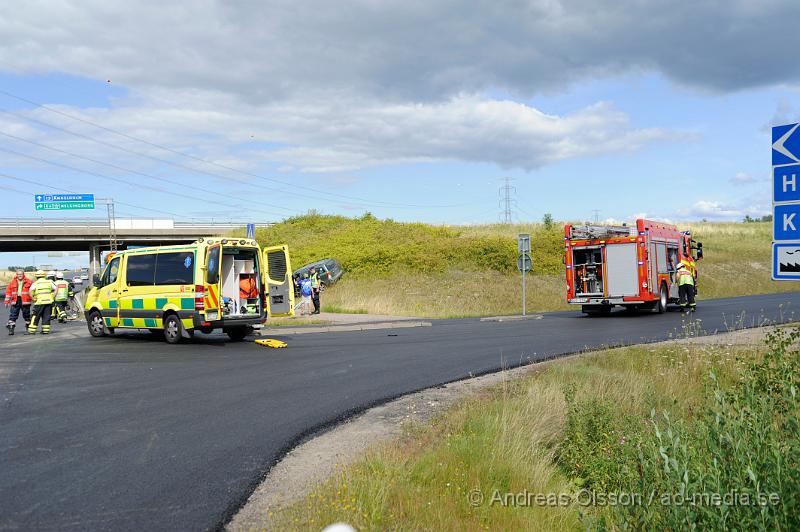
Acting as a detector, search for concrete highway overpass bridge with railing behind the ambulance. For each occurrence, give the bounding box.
[0,218,272,275]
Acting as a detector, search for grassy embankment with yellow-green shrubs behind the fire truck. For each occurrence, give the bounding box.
[257,214,794,317]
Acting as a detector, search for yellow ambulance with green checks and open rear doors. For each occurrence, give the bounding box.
[85,238,294,344]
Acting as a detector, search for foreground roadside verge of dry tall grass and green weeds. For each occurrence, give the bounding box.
[273,330,800,530]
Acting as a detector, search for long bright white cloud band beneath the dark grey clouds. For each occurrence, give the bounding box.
[0,92,678,172]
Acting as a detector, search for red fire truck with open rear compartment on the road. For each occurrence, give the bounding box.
[564,219,703,315]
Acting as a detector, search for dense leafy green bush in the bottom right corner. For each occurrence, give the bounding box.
[616,329,800,530]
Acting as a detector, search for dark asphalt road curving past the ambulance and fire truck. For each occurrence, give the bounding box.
[0,293,800,530]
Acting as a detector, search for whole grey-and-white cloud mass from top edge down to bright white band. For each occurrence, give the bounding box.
[0,0,800,177]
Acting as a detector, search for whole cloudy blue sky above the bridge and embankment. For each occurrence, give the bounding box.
[0,0,800,264]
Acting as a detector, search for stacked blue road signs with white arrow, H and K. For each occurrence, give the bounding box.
[772,124,800,281]
